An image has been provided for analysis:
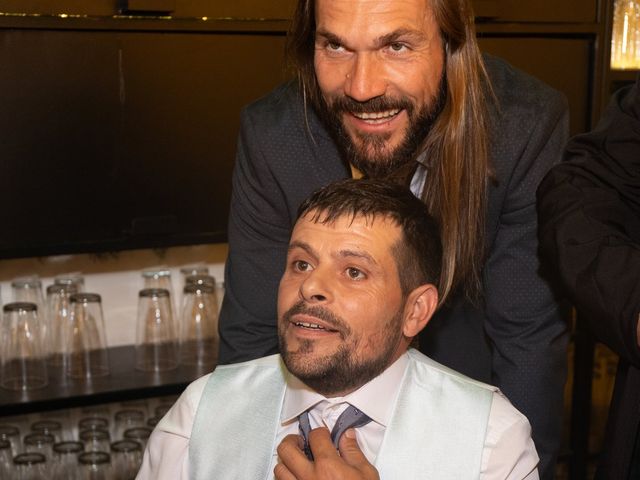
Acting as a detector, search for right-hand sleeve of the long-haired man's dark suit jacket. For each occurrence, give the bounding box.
[484,70,568,478]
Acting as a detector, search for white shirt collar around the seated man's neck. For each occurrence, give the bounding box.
[280,352,408,427]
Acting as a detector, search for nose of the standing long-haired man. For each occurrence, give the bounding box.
[344,52,387,102]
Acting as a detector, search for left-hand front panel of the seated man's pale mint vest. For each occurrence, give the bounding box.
[189,356,285,480]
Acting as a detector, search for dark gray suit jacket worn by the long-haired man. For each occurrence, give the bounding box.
[220,53,568,478]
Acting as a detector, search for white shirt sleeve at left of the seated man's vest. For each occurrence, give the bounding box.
[136,375,209,480]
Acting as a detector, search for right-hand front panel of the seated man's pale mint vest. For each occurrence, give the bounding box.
[375,348,493,480]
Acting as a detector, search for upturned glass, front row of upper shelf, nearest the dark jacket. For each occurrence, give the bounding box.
[180,284,218,368]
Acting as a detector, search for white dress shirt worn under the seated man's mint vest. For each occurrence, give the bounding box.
[136,354,539,480]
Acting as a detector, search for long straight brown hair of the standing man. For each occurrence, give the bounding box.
[287,0,495,304]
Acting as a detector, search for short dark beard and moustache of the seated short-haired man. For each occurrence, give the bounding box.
[278,301,402,396]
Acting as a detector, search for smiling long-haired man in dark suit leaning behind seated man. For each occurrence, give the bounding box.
[220,0,567,478]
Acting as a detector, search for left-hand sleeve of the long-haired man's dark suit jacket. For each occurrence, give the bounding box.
[219,102,291,363]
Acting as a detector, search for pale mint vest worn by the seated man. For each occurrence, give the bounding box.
[189,350,496,480]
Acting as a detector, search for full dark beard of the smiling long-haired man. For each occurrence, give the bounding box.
[317,76,447,178]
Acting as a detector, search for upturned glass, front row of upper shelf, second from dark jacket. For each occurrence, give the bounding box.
[136,288,178,372]
